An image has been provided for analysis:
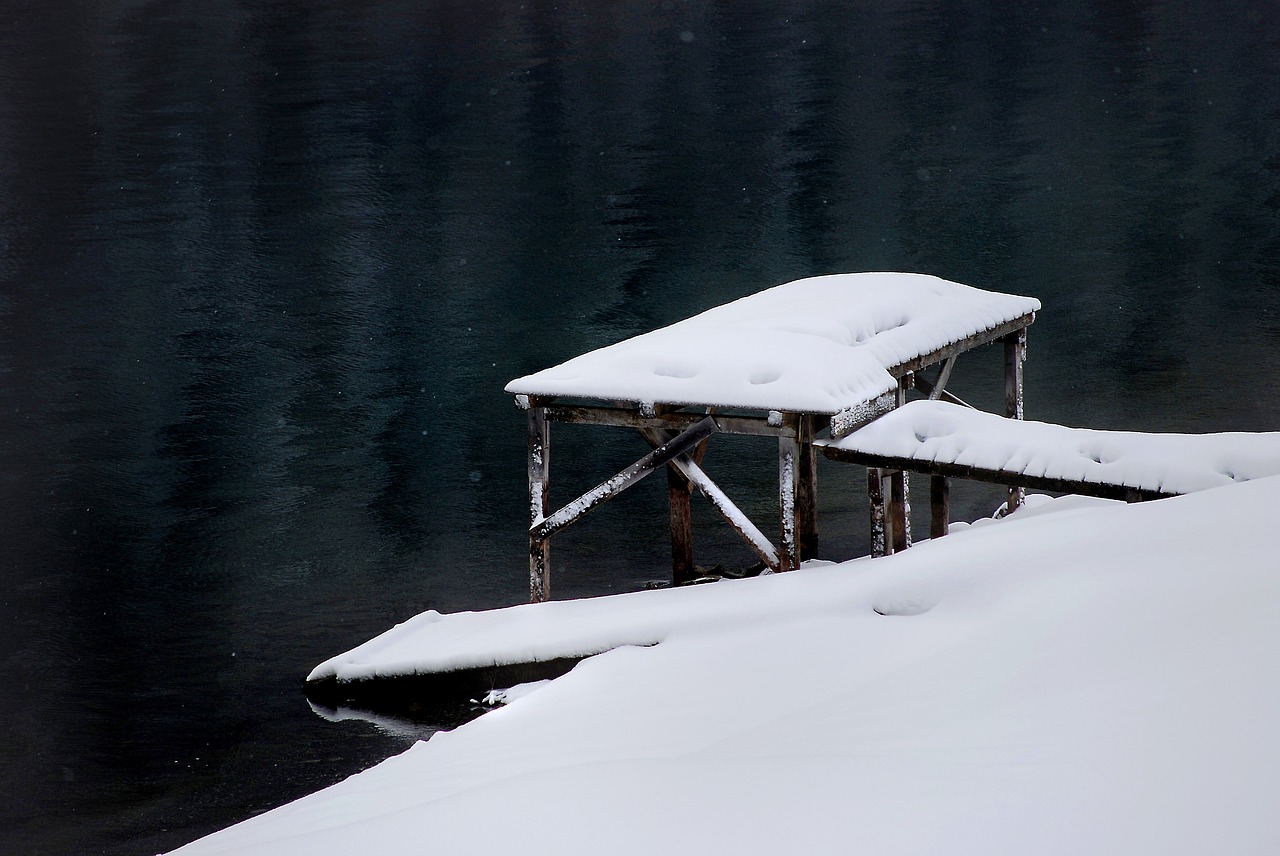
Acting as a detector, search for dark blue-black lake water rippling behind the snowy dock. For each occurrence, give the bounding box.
[0,0,1280,855]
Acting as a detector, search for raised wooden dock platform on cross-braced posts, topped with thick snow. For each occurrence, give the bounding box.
[507,273,1041,601]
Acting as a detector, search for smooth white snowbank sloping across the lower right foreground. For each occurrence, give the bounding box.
[179,479,1280,856]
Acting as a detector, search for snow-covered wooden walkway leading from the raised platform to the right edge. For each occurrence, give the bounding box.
[819,400,1280,498]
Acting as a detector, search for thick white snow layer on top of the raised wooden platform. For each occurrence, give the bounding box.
[507,273,1039,415]
